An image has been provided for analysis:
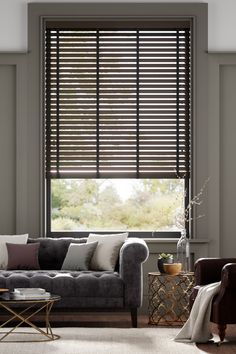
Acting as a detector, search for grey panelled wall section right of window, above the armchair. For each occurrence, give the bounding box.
[208,53,236,257]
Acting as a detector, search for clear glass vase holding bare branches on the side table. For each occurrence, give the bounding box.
[177,229,190,273]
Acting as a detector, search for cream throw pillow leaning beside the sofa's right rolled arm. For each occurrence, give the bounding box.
[87,232,128,271]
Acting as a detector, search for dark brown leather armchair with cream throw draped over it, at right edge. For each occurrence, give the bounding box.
[189,258,236,341]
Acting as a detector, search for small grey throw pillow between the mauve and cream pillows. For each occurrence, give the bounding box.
[61,242,98,270]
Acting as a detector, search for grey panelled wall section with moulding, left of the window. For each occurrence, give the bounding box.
[0,54,28,234]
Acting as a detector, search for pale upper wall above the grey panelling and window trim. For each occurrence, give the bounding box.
[0,0,236,52]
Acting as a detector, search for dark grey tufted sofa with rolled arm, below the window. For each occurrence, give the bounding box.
[0,238,148,327]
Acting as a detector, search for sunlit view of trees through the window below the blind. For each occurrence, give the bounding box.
[51,179,185,231]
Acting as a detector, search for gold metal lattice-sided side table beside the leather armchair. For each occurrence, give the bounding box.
[148,272,194,326]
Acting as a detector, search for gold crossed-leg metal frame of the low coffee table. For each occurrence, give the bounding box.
[0,294,61,342]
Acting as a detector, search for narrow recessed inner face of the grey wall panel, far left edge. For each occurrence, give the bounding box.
[0,64,16,233]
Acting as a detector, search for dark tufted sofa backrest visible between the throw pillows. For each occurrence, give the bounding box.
[28,237,87,270]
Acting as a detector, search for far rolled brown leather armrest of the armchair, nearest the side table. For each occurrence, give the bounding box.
[194,258,236,285]
